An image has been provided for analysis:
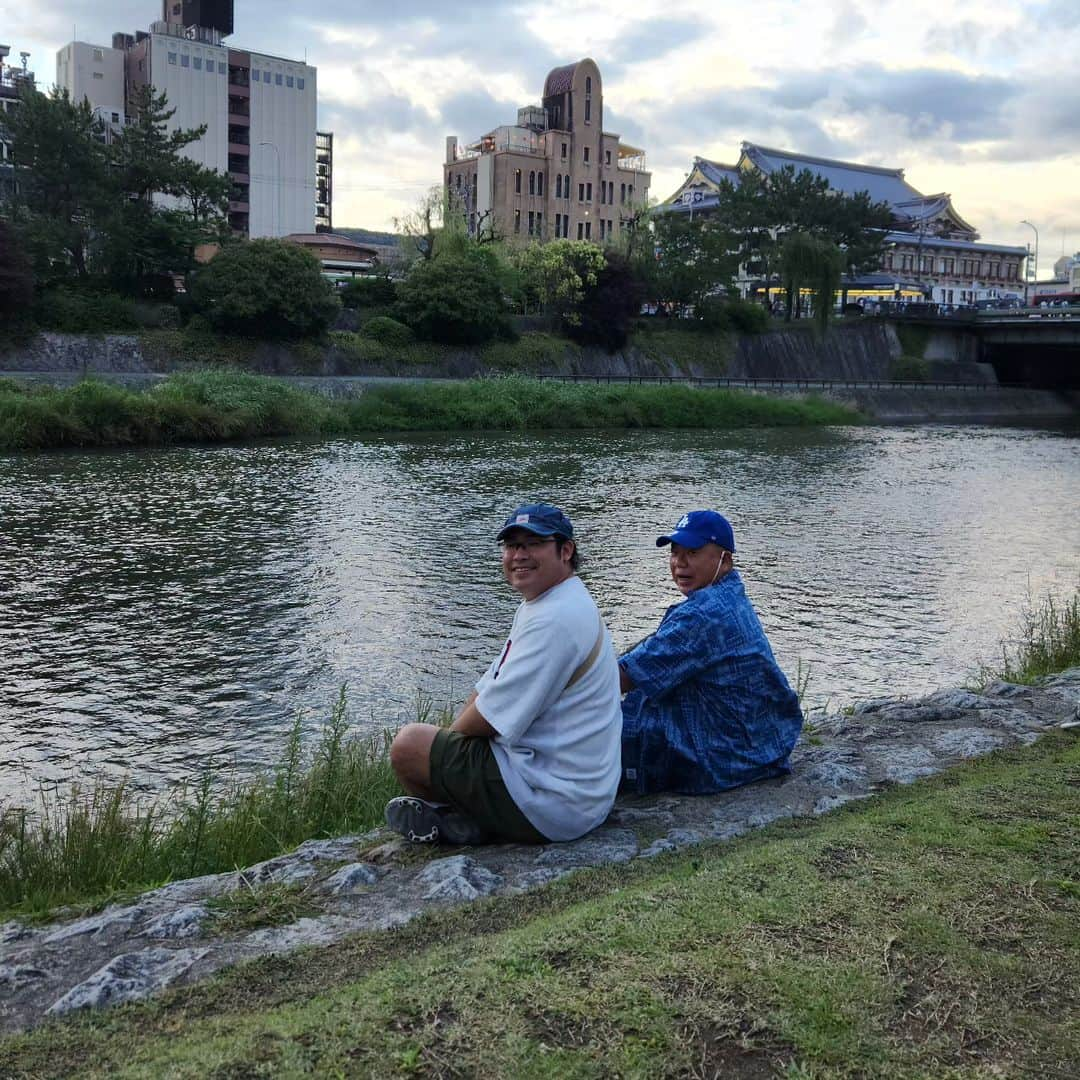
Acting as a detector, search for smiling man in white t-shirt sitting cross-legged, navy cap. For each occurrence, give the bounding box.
[387,502,622,843]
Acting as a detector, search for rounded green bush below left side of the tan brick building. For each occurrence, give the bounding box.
[397,244,510,345]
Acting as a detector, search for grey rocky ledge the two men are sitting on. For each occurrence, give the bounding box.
[0,667,1080,1031]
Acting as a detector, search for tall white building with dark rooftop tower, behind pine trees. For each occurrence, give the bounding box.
[56,0,316,238]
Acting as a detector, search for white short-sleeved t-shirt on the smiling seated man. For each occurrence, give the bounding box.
[476,577,622,840]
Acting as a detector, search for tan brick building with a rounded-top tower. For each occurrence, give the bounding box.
[443,59,651,244]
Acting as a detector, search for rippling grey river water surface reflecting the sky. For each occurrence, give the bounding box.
[0,428,1080,799]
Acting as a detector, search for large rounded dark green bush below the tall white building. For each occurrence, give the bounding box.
[190,240,339,338]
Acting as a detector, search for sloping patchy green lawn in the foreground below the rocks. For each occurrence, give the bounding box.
[0,733,1080,1080]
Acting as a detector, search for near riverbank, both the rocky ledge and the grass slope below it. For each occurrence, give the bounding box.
[0,695,1080,1078]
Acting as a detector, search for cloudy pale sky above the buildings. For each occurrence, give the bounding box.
[0,0,1080,272]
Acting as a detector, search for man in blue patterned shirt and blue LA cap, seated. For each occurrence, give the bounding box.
[619,510,802,795]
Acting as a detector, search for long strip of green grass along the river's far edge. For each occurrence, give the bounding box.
[0,372,860,450]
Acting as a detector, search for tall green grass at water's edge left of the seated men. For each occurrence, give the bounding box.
[0,691,408,919]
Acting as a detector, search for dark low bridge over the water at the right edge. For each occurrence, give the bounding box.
[872,303,1080,390]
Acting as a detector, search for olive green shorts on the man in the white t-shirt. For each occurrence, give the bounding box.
[428,728,549,843]
